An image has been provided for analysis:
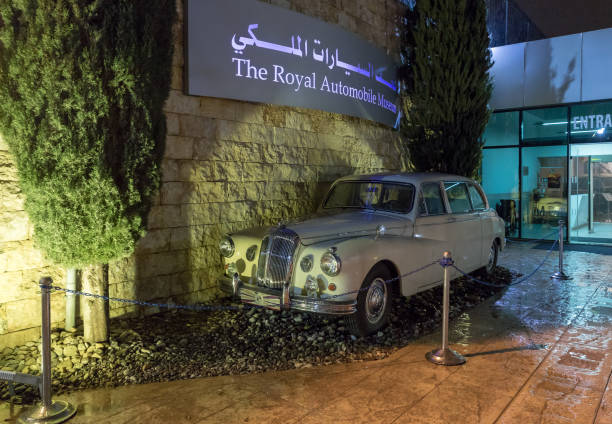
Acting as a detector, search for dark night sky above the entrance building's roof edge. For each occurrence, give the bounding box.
[515,0,612,38]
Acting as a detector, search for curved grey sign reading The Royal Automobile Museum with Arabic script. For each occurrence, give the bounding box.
[185,0,399,126]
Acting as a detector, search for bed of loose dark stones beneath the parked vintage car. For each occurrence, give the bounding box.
[0,267,517,403]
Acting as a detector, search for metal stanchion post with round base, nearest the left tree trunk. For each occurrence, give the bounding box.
[17,277,76,424]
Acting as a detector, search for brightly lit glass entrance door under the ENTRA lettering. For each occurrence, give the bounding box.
[568,143,612,245]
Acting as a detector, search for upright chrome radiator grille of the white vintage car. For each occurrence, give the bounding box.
[257,228,300,289]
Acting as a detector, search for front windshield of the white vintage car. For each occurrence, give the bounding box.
[323,181,414,213]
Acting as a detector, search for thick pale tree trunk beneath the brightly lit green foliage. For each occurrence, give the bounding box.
[81,265,109,343]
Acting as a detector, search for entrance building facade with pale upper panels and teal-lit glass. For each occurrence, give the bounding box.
[482,29,612,244]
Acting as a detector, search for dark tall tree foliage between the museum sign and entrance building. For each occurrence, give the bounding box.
[400,0,492,177]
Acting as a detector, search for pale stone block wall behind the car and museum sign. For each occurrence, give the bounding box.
[0,0,402,346]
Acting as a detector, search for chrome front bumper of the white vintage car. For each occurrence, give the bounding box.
[218,275,357,315]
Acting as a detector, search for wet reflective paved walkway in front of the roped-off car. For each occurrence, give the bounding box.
[0,244,612,424]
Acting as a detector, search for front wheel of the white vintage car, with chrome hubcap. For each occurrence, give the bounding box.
[347,264,396,337]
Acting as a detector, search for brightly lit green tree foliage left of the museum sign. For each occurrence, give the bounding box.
[0,0,176,266]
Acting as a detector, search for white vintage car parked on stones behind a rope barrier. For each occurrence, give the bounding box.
[219,173,505,335]
